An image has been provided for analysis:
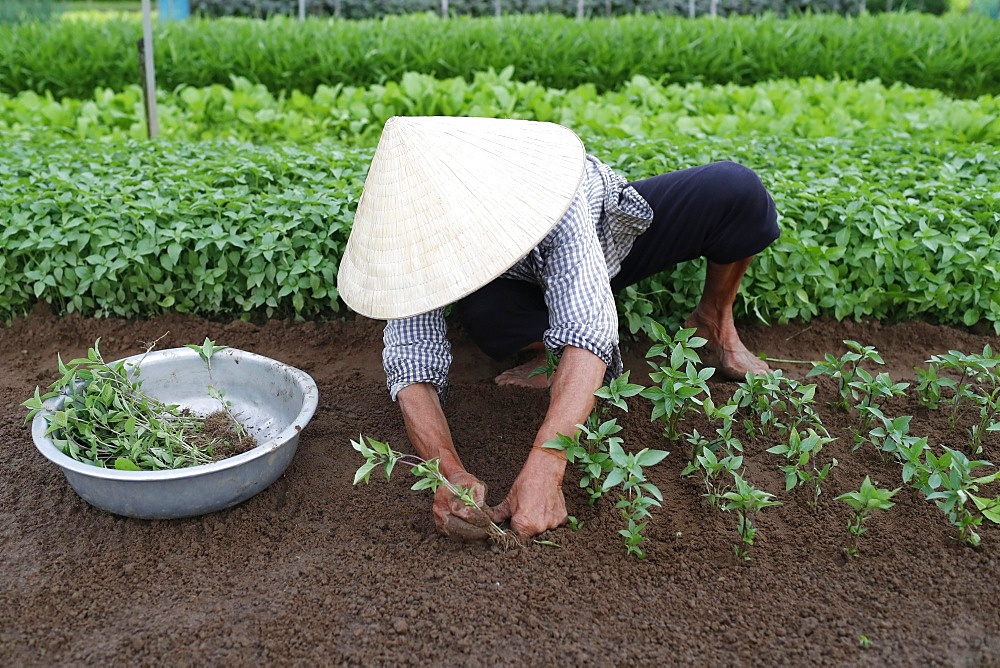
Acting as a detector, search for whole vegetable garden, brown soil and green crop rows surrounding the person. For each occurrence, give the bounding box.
[0,7,1000,666]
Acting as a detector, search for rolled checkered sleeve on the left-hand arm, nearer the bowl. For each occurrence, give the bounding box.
[382,308,451,401]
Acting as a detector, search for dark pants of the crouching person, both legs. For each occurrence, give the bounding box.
[455,162,778,360]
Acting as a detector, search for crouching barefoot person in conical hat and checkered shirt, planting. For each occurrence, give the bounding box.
[338,117,779,538]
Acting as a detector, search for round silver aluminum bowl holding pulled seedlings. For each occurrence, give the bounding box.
[31,348,319,519]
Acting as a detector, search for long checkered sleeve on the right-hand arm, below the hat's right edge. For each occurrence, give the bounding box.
[538,194,622,378]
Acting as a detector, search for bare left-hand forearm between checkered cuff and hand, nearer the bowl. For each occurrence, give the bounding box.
[397,383,465,478]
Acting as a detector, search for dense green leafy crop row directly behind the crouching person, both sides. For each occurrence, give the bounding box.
[0,130,1000,332]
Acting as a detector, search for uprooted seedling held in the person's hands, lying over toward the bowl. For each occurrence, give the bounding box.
[351,435,520,548]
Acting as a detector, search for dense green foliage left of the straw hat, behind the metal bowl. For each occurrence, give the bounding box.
[0,134,360,319]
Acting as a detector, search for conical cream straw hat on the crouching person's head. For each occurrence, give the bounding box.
[337,116,586,319]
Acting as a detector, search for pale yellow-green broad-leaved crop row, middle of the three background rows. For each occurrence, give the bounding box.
[7,68,1000,146]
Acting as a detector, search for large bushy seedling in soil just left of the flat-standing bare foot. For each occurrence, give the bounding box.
[640,323,715,441]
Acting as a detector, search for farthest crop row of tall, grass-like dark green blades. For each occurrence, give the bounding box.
[0,14,1000,99]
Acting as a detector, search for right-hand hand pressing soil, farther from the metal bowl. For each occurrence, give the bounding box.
[492,448,566,540]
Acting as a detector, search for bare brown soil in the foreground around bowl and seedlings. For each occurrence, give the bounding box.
[0,309,1000,666]
